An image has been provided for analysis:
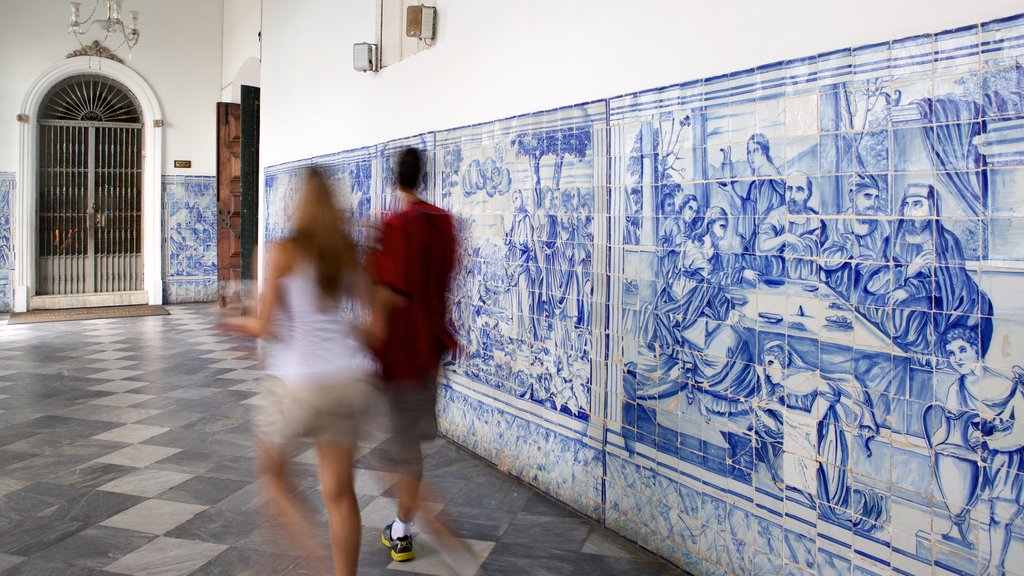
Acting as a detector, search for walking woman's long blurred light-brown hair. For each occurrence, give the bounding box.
[287,168,359,298]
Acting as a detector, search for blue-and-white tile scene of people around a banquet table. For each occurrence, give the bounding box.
[609,14,1024,574]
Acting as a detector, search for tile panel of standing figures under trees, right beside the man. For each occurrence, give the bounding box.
[434,105,604,429]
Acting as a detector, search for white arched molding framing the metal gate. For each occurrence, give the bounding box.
[13,56,164,312]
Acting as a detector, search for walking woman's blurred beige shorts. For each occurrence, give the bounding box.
[253,374,386,446]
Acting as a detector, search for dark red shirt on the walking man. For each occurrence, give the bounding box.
[370,199,456,382]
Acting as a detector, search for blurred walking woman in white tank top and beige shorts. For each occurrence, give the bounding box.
[226,169,379,576]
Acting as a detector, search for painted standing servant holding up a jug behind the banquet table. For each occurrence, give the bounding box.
[722,132,785,253]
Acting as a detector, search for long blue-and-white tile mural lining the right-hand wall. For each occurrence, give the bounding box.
[264,17,1024,575]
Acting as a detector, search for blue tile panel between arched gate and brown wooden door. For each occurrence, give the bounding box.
[163,176,217,303]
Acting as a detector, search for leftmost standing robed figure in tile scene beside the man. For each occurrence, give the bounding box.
[505,190,542,342]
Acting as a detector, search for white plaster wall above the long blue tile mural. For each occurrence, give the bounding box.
[260,0,1022,165]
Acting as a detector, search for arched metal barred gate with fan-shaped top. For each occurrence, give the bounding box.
[36,76,142,295]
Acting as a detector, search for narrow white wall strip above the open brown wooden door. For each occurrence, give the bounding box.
[220,0,263,102]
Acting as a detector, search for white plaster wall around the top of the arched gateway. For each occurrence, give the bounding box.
[0,0,223,175]
